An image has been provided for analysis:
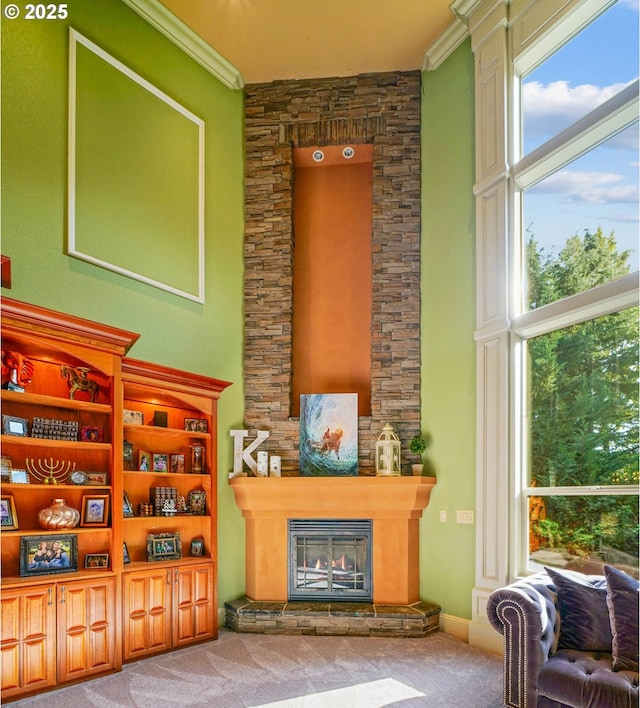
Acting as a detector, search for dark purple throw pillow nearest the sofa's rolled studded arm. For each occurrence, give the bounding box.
[545,568,611,652]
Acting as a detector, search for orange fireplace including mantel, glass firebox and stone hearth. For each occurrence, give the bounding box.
[225,476,440,637]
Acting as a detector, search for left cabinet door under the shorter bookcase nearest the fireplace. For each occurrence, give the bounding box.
[123,568,173,661]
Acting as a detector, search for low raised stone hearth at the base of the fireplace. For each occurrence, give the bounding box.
[225,597,440,638]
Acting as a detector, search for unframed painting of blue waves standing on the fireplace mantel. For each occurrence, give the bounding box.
[300,393,358,477]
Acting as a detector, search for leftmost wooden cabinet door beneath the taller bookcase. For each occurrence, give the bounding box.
[1,584,56,699]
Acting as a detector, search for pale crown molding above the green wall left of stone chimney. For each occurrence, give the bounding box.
[123,0,244,90]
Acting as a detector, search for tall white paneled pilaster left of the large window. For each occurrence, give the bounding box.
[460,0,511,646]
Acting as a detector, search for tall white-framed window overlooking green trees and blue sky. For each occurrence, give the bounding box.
[511,0,639,571]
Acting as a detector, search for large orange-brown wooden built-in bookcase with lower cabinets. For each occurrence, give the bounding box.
[0,298,229,701]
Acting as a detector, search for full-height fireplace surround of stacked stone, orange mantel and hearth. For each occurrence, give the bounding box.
[234,71,430,636]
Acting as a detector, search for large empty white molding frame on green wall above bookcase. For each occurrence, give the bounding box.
[68,29,205,302]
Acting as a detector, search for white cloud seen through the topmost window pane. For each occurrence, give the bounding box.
[522,81,628,135]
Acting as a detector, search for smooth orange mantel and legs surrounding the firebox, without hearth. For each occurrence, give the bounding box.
[230,477,436,605]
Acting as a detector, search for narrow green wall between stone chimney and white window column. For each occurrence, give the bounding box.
[420,40,476,619]
